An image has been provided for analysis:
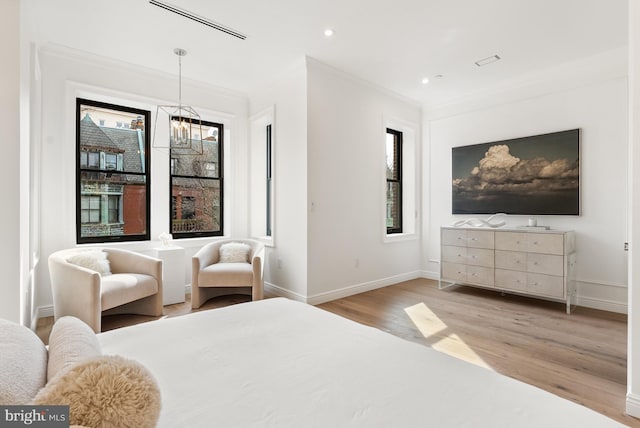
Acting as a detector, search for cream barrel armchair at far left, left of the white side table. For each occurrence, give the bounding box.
[49,248,162,333]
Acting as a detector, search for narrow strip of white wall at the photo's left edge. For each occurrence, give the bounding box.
[0,0,22,322]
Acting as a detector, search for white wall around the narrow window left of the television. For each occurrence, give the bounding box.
[306,59,421,303]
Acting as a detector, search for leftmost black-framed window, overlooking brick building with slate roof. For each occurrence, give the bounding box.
[76,98,151,244]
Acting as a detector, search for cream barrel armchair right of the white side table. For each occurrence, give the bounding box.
[191,239,265,309]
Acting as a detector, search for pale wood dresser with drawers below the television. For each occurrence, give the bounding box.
[440,227,575,313]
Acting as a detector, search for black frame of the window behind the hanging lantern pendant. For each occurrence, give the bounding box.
[169,116,224,239]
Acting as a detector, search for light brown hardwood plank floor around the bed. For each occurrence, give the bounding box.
[37,279,640,427]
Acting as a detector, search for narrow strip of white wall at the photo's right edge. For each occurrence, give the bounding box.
[626,1,640,417]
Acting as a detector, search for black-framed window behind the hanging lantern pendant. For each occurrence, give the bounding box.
[170,117,224,238]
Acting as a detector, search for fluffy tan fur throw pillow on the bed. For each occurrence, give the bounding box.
[33,355,161,428]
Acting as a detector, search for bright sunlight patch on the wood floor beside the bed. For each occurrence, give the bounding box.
[404,303,491,369]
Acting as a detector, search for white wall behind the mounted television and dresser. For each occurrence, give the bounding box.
[424,50,628,312]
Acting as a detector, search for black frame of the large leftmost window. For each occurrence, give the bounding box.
[76,98,151,244]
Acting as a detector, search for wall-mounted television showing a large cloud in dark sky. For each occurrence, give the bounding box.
[451,129,580,215]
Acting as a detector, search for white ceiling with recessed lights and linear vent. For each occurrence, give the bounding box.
[23,0,628,107]
